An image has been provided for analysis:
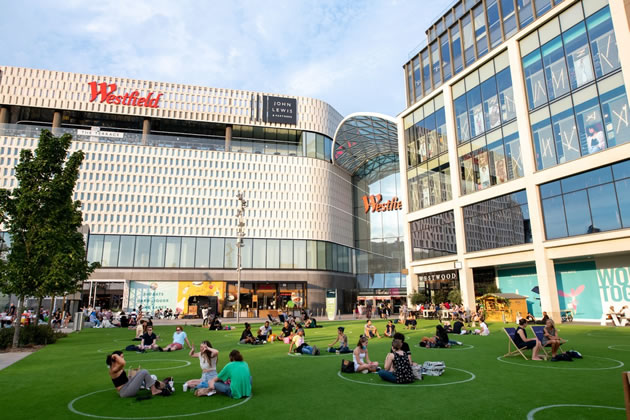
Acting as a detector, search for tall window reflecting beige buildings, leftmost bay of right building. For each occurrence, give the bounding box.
[404,95,452,212]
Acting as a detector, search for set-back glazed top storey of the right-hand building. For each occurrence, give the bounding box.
[405,0,562,105]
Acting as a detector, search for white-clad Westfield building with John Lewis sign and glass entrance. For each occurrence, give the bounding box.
[0,62,406,317]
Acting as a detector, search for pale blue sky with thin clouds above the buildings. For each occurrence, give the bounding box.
[0,0,452,116]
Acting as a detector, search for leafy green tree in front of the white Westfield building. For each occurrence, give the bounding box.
[0,130,98,347]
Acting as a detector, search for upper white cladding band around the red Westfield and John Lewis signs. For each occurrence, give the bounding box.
[0,66,342,138]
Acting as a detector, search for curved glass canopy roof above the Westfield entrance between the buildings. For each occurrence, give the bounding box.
[333,113,398,175]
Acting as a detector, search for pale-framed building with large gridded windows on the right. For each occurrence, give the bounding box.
[399,0,630,320]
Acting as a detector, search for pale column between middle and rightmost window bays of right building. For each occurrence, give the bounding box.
[508,40,561,322]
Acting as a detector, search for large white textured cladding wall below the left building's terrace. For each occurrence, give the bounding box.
[0,136,353,247]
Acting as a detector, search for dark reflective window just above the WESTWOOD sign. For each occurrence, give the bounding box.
[411,211,457,261]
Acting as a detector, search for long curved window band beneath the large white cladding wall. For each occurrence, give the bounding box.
[86,233,356,273]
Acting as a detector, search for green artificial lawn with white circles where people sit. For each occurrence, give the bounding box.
[0,320,630,420]
